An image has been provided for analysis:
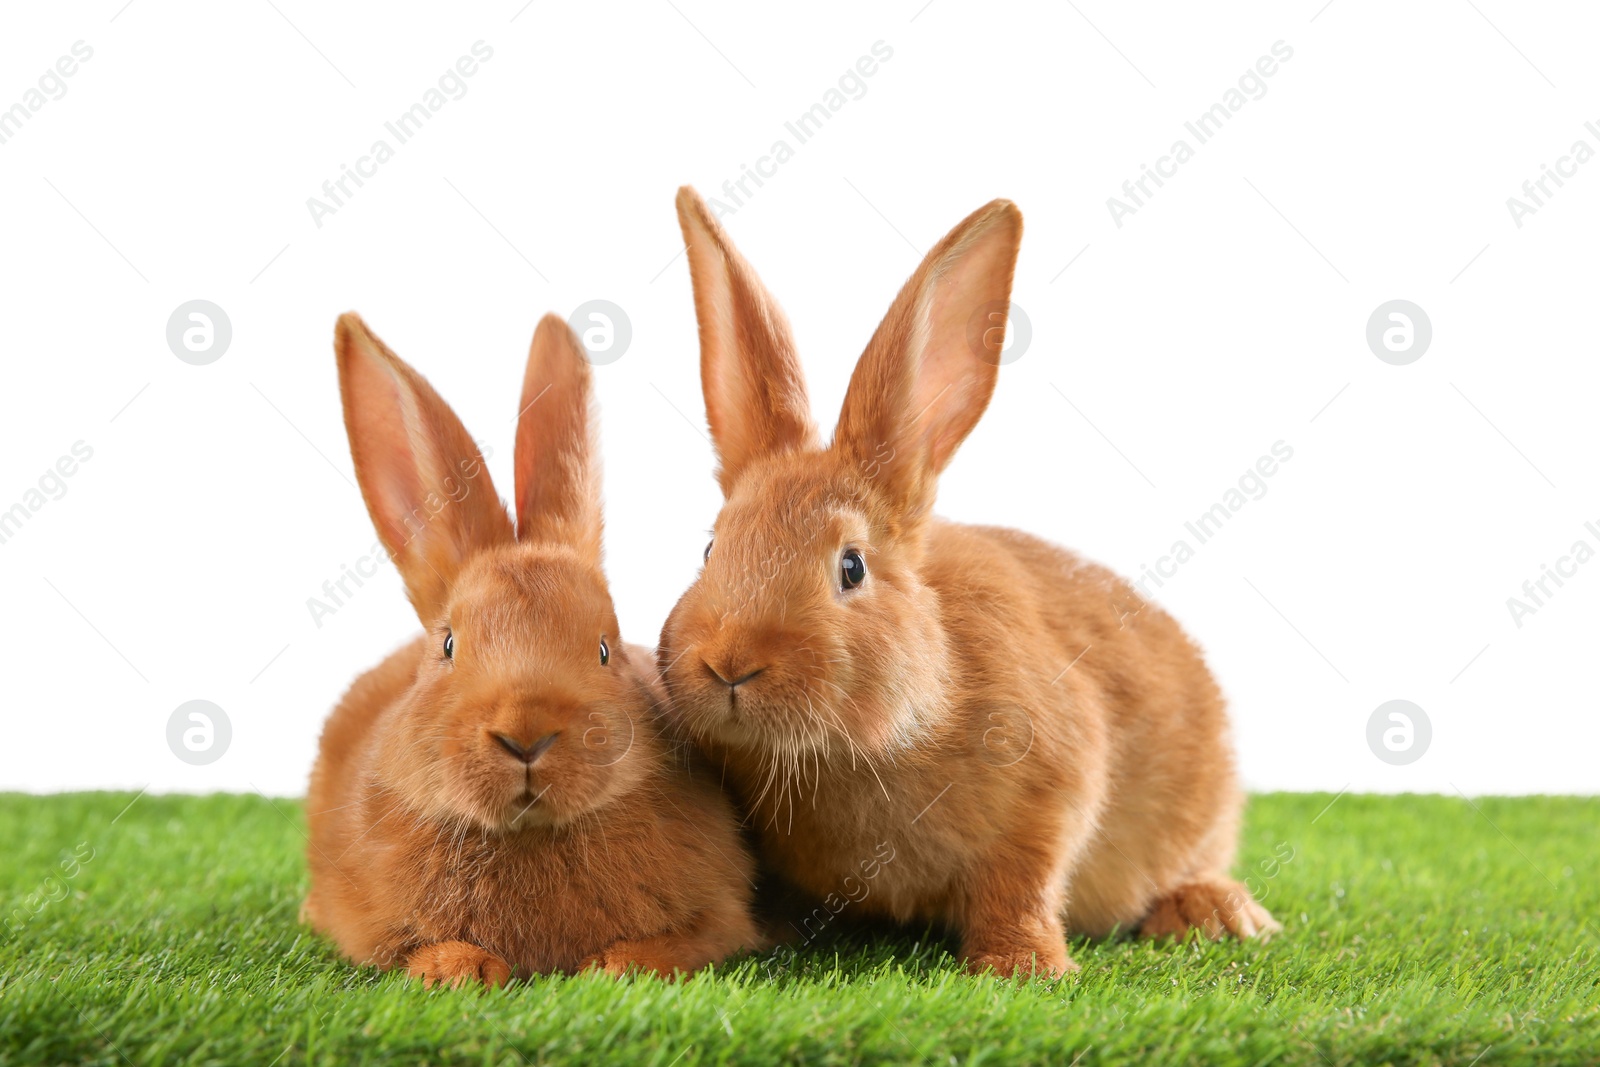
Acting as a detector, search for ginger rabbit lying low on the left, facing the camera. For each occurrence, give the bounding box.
[302,314,757,985]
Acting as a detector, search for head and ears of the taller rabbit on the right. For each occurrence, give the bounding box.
[661,189,1022,763]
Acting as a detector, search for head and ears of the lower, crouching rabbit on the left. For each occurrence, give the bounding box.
[336,314,659,832]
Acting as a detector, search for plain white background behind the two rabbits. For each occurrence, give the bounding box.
[0,0,1600,795]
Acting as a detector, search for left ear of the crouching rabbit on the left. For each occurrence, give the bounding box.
[334,314,512,627]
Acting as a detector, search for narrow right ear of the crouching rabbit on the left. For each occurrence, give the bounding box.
[515,312,600,566]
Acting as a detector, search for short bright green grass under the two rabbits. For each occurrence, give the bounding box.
[0,793,1600,1067]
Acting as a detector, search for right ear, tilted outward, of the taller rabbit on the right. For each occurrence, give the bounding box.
[834,200,1022,512]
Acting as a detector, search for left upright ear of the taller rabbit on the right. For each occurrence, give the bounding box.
[678,186,819,494]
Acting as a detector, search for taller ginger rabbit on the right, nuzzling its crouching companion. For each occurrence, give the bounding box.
[658,187,1278,976]
